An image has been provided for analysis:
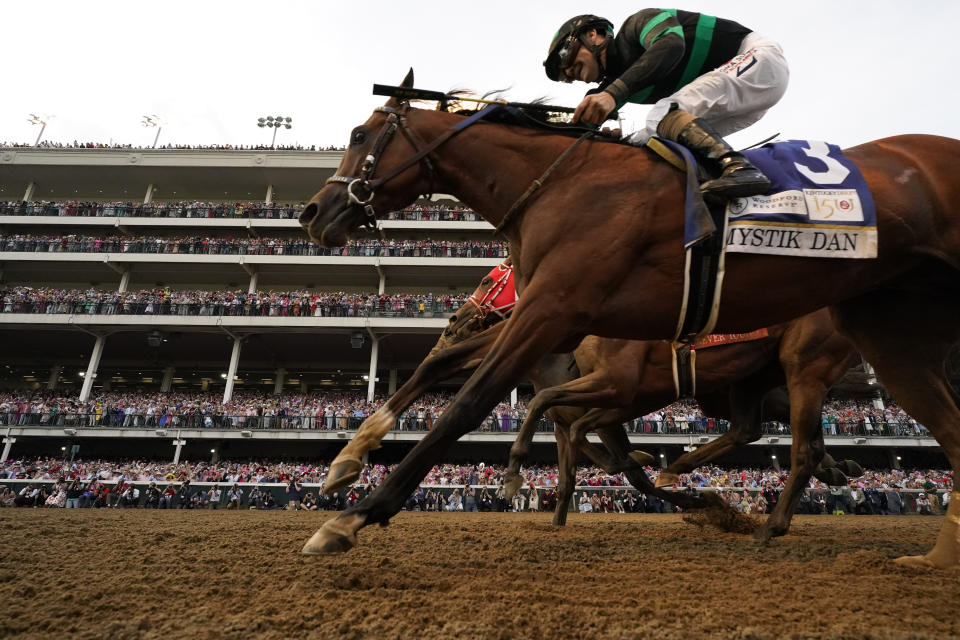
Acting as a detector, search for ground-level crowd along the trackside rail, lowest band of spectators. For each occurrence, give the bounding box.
[0,458,953,515]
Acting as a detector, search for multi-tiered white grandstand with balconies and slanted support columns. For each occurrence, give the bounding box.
[0,145,946,468]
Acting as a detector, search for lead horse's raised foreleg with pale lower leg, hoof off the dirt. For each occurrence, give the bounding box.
[323,324,503,493]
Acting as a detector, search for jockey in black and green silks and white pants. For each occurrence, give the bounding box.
[543,9,790,198]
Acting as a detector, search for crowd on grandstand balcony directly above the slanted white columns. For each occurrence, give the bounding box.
[0,285,470,318]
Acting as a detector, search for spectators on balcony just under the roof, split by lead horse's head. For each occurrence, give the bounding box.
[0,200,482,222]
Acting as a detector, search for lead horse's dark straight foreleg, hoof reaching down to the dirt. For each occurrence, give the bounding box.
[303,306,573,555]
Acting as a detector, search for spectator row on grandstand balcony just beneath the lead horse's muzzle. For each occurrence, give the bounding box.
[0,234,508,259]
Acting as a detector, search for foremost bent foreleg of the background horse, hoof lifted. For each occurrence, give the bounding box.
[504,373,616,499]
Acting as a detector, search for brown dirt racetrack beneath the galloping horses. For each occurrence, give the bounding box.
[0,509,960,640]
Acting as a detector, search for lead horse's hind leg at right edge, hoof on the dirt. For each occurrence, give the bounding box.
[833,292,960,568]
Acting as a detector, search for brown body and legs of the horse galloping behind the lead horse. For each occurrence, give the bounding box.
[507,309,860,539]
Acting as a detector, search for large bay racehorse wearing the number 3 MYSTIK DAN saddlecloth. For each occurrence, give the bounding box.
[300,72,960,566]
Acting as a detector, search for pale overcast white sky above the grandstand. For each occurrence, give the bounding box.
[0,0,960,146]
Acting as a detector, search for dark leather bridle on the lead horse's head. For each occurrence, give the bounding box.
[325,100,500,231]
